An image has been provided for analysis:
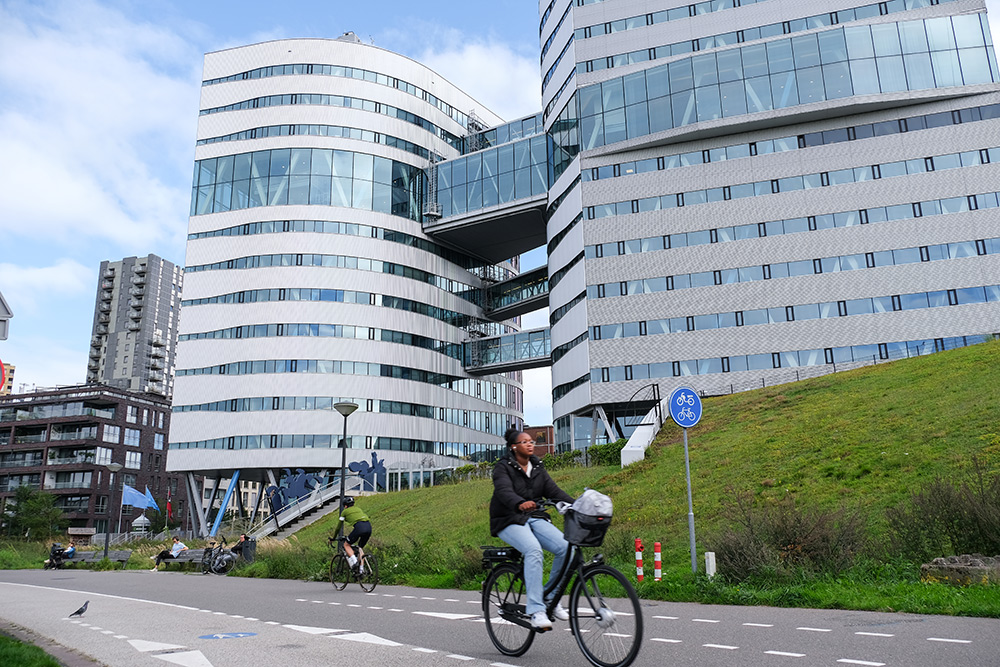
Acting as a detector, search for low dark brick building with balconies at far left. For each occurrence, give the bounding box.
[0,384,191,535]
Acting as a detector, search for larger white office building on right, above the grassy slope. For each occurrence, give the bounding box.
[540,0,1000,447]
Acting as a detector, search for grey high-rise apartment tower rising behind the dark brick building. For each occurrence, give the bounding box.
[87,255,184,397]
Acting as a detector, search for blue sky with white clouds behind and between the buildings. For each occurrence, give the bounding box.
[0,0,551,424]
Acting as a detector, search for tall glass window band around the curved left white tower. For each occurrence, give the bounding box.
[191,147,425,220]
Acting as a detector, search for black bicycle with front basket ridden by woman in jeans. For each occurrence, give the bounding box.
[482,502,642,667]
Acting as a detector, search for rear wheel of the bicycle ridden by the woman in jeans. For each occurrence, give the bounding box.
[483,563,535,656]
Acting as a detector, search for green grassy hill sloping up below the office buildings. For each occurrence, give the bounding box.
[264,341,1000,615]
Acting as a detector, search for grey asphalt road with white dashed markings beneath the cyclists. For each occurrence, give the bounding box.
[0,570,1000,667]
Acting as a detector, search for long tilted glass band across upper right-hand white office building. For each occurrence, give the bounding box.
[578,14,1000,150]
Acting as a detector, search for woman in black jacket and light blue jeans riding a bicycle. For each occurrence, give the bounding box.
[490,427,573,630]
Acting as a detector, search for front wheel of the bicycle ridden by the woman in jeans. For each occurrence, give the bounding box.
[569,565,642,667]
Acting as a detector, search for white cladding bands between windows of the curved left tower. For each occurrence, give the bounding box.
[171,40,521,470]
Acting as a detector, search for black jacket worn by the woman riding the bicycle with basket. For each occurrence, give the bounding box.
[490,455,573,537]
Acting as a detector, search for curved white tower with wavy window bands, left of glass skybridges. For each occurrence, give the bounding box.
[170,34,532,536]
